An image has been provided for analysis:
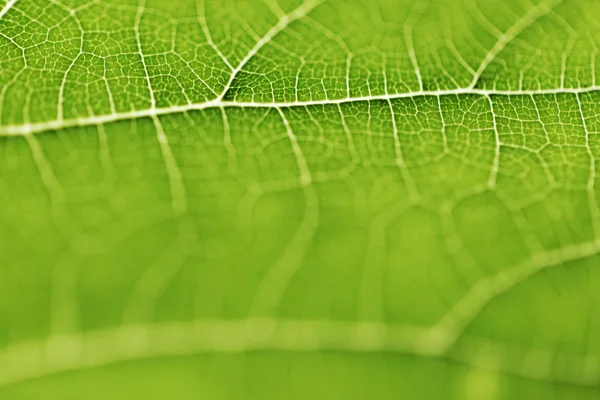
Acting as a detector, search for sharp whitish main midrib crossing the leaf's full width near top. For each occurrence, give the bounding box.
[0,86,600,136]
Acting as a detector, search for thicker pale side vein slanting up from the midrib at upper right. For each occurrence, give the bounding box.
[469,0,562,88]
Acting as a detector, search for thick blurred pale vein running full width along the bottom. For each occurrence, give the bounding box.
[0,318,600,387]
